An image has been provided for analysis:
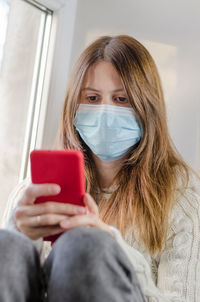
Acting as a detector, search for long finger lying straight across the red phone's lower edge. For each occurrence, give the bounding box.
[15,201,87,219]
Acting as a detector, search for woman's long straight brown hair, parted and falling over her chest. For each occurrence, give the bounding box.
[60,35,188,253]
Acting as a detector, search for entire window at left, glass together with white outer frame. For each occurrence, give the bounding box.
[0,0,77,224]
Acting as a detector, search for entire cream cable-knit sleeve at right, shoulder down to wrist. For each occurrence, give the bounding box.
[109,185,200,302]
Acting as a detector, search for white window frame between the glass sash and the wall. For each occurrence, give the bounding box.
[19,0,77,181]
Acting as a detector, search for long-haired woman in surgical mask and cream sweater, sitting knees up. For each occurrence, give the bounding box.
[0,36,200,302]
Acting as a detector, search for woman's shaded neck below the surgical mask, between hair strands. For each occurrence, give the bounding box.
[93,154,124,188]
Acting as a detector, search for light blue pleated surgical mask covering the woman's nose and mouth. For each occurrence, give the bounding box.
[74,104,142,161]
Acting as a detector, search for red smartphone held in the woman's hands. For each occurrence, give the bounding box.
[30,150,85,243]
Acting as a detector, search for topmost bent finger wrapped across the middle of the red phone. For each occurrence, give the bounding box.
[19,184,61,205]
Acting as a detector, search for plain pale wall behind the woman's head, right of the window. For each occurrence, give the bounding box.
[64,0,200,170]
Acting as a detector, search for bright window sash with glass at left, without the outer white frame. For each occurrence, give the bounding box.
[0,0,52,214]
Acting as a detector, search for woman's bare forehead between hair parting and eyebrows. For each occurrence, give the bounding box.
[82,61,123,90]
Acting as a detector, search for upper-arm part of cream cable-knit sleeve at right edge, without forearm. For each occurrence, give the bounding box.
[157,189,200,302]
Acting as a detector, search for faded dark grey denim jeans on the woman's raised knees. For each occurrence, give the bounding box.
[0,227,145,302]
